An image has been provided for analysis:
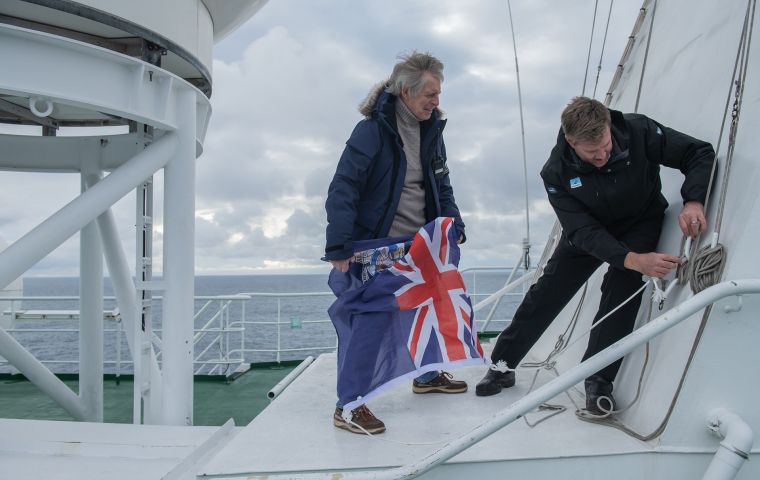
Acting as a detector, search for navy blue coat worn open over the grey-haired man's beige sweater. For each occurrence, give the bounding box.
[325,91,464,260]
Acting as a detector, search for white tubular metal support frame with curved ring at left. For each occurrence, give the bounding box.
[0,4,210,425]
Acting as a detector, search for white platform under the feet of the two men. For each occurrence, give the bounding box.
[199,348,655,478]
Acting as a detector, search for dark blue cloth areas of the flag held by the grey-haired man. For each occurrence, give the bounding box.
[328,219,483,408]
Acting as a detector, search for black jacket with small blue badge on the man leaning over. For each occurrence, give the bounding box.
[541,110,715,268]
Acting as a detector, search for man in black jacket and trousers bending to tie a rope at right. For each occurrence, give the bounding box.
[476,97,715,414]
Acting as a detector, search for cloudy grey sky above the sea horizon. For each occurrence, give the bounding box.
[0,0,642,276]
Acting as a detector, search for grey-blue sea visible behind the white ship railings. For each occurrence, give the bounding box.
[0,271,519,374]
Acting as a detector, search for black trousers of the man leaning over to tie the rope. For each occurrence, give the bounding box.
[491,215,662,382]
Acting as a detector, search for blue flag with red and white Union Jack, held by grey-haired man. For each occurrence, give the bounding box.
[328,218,486,410]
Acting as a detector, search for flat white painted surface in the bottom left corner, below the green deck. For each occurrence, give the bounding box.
[0,419,237,480]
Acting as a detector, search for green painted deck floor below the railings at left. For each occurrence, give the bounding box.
[0,362,298,426]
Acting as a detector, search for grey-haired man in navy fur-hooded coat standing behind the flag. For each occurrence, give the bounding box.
[324,51,467,433]
